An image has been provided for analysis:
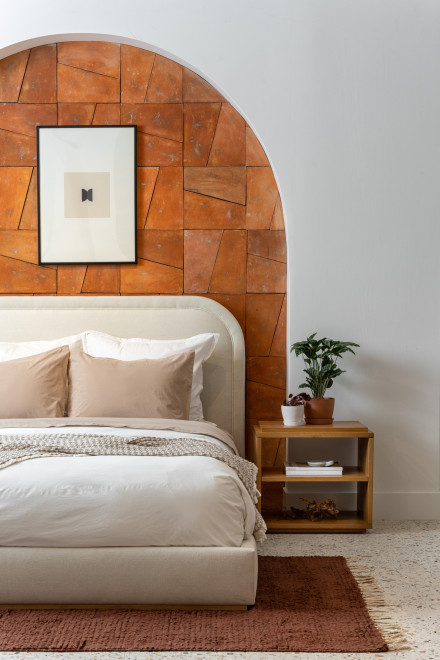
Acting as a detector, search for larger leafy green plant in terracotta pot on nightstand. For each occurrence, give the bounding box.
[290,332,359,424]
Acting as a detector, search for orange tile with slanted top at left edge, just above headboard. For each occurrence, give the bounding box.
[0,257,57,293]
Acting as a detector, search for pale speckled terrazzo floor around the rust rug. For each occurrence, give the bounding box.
[0,521,440,660]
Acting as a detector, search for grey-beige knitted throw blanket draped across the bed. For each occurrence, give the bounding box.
[0,433,266,541]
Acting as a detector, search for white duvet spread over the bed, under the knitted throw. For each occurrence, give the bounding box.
[0,426,255,547]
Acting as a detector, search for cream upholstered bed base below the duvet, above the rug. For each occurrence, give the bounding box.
[0,538,258,609]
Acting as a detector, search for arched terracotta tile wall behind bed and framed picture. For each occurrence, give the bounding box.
[0,42,286,454]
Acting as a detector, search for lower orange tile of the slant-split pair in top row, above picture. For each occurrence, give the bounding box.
[58,64,120,103]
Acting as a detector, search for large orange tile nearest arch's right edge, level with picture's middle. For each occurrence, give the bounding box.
[246,167,278,229]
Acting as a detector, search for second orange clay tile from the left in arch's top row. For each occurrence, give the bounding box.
[19,44,57,103]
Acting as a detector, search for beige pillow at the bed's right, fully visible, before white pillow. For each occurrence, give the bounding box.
[68,350,194,419]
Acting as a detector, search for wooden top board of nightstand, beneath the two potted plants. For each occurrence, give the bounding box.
[255,420,374,438]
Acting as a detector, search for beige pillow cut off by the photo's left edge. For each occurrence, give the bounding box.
[0,346,69,419]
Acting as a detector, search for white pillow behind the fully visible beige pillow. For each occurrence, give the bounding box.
[82,330,219,421]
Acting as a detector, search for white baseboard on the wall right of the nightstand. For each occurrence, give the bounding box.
[373,491,440,520]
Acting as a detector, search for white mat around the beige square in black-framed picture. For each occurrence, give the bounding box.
[39,126,136,263]
